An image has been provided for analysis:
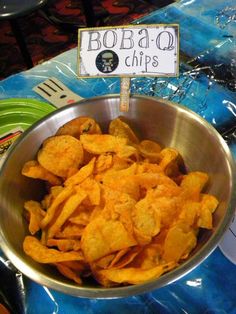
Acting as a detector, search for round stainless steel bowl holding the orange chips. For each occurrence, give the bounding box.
[0,95,235,298]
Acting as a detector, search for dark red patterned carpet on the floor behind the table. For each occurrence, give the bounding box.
[0,0,157,80]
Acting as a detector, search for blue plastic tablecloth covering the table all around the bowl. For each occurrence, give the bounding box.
[0,0,236,314]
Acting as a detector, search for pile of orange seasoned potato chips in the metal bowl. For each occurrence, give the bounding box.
[22,117,218,287]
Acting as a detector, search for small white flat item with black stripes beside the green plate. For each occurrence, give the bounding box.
[33,77,83,108]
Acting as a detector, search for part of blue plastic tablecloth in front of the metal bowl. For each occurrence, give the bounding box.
[0,249,236,314]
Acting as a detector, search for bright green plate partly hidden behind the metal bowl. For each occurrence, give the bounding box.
[0,98,56,135]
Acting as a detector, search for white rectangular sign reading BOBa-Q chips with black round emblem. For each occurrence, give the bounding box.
[78,24,179,77]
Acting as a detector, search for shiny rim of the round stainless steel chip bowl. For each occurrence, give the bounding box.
[0,94,236,299]
